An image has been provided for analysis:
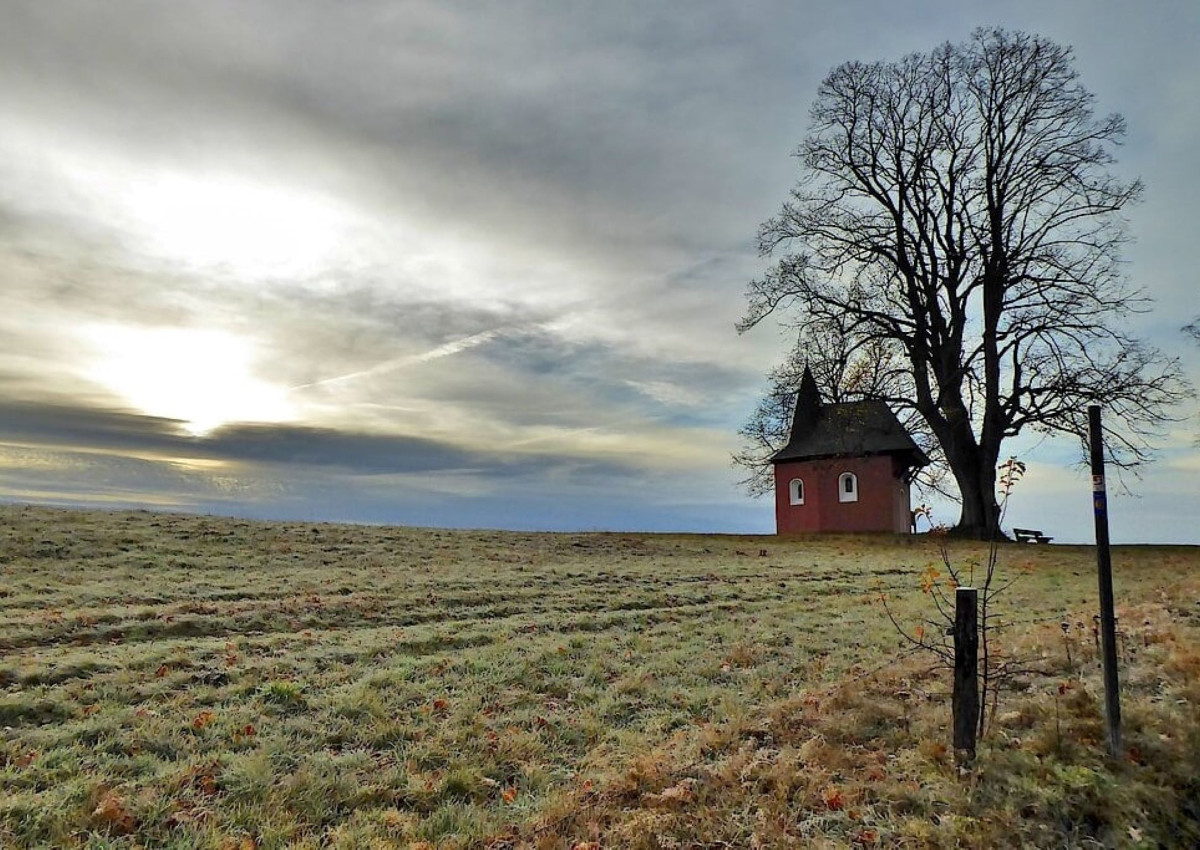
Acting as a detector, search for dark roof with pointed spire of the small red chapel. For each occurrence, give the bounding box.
[770,367,929,467]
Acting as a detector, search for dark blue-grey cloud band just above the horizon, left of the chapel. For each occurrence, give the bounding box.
[0,403,762,531]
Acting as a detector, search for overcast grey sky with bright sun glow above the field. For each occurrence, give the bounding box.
[0,0,1200,543]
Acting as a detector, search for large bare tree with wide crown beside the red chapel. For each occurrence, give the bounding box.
[739,29,1186,538]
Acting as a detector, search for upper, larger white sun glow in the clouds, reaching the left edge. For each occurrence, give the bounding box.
[0,120,350,281]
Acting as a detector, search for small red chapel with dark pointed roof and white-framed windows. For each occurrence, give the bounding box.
[770,367,929,534]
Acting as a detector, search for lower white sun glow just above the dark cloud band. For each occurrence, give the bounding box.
[80,324,295,436]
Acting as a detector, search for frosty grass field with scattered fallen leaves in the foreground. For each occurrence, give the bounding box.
[0,505,1200,850]
